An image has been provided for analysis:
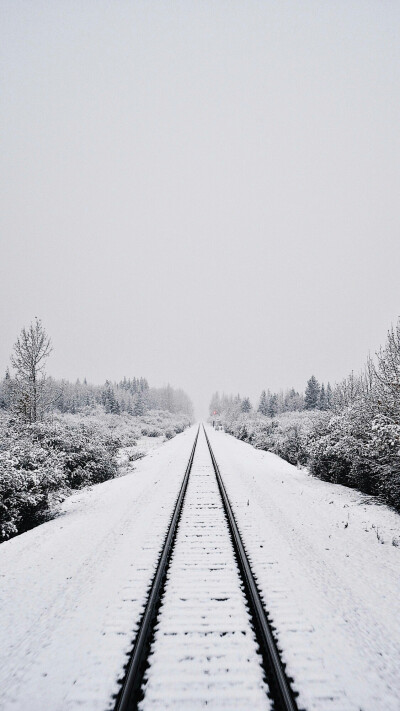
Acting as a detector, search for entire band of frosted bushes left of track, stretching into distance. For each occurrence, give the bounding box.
[0,406,191,541]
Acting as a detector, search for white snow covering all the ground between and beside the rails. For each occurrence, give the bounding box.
[0,428,400,711]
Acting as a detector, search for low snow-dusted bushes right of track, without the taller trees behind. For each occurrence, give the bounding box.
[216,397,400,511]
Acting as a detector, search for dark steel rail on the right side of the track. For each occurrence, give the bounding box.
[203,425,298,711]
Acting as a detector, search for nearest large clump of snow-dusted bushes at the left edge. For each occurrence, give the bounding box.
[0,416,119,540]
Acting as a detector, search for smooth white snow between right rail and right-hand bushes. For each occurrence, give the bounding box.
[207,427,400,711]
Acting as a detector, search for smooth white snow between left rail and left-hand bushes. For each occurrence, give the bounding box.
[0,428,196,711]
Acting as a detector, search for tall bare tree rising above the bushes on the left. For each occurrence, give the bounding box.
[11,318,53,422]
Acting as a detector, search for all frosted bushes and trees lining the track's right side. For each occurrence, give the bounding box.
[214,321,400,511]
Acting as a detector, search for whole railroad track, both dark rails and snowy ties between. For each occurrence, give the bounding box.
[115,427,297,711]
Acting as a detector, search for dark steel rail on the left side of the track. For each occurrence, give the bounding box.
[115,426,200,711]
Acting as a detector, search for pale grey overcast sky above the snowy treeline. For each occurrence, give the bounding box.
[0,0,400,415]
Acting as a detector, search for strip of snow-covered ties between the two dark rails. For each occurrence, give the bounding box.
[139,430,271,711]
